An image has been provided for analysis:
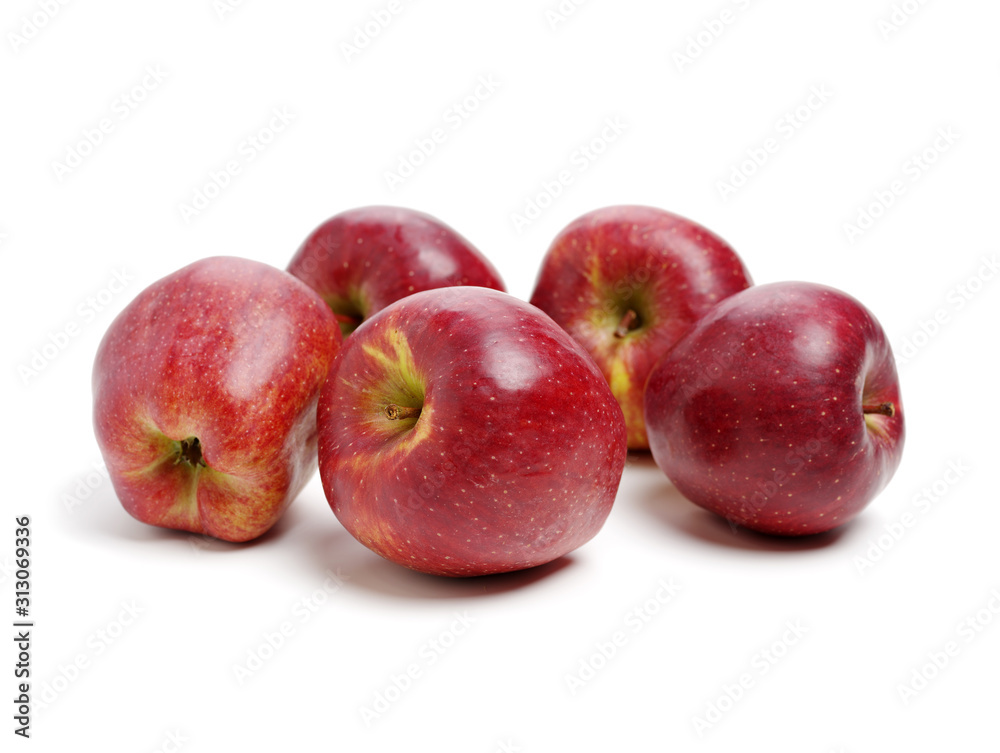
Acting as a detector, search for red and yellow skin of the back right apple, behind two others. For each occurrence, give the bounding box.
[531,206,752,450]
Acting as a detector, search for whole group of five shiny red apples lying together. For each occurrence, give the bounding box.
[93,206,904,576]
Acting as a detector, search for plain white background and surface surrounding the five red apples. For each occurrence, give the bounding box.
[0,0,1000,753]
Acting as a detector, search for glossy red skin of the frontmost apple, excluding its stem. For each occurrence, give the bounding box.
[319,287,626,576]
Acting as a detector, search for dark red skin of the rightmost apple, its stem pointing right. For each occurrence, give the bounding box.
[645,282,905,536]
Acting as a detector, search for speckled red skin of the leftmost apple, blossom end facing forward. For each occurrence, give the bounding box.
[93,257,341,541]
